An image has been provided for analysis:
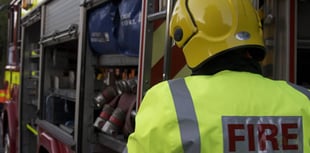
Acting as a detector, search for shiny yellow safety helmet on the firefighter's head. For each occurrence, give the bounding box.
[170,0,265,69]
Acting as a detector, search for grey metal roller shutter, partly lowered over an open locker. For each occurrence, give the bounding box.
[44,0,80,35]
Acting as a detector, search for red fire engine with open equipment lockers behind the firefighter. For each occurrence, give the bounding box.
[0,0,310,153]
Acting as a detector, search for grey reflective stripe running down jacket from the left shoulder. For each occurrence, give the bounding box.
[168,79,200,153]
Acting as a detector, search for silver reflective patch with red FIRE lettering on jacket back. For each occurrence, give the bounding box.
[222,116,303,153]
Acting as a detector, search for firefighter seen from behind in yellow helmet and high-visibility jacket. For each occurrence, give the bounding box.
[124,0,310,153]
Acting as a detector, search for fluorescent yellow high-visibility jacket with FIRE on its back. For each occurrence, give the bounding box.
[124,71,310,153]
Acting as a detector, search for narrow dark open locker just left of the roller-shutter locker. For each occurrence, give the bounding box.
[18,10,41,153]
